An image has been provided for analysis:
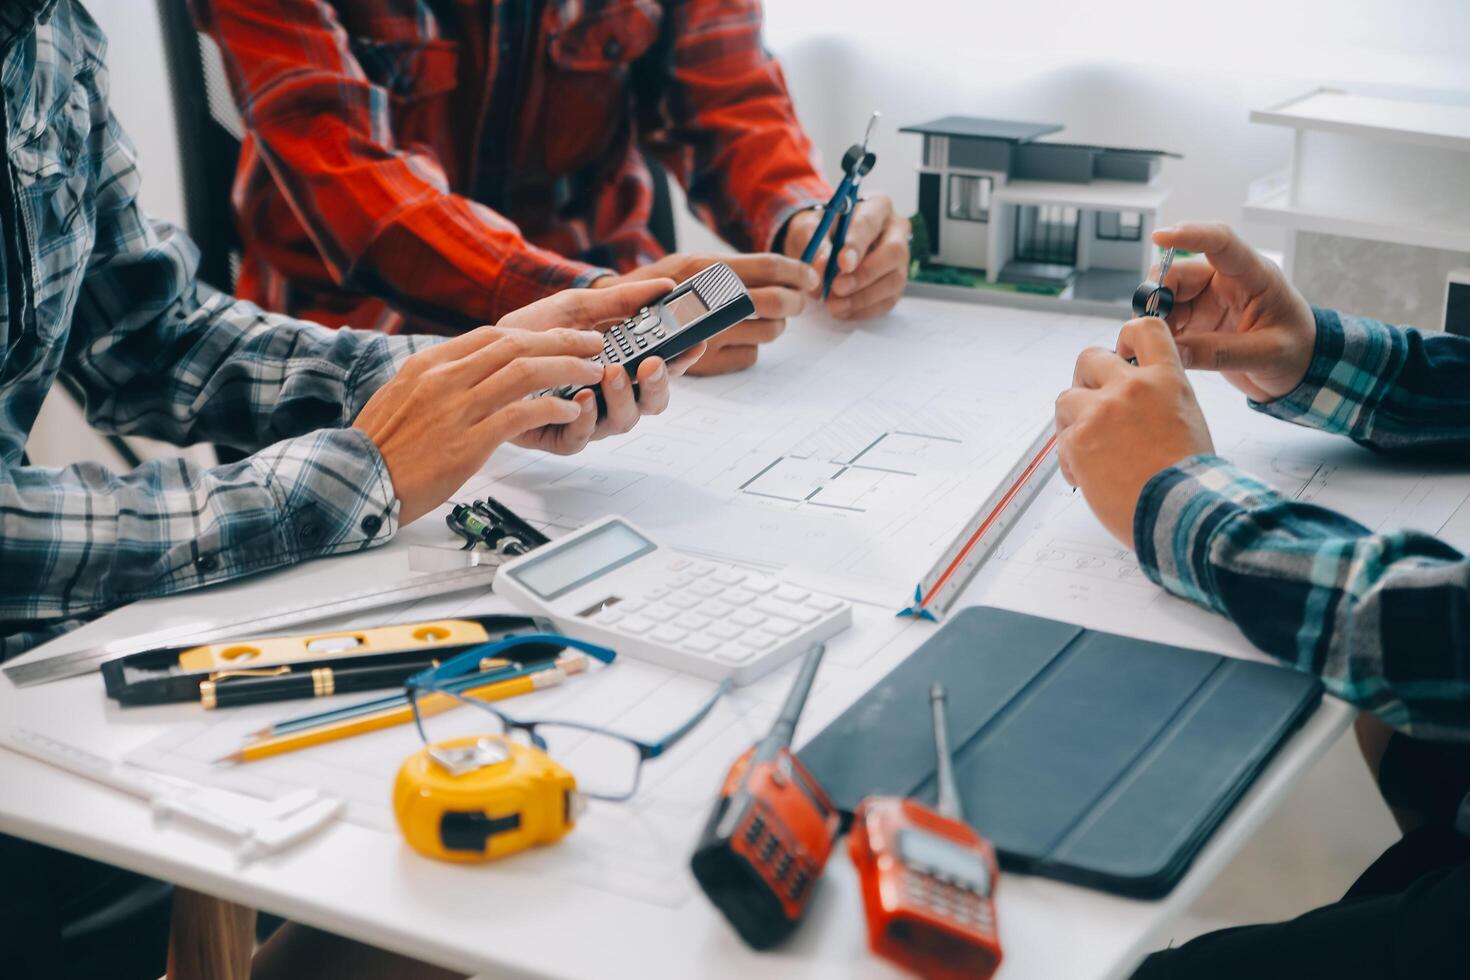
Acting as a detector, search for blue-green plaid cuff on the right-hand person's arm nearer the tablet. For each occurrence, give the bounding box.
[1133,455,1283,613]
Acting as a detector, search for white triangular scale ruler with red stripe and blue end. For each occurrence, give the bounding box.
[898,422,1057,621]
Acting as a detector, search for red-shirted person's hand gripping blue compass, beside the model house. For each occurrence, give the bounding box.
[784,194,911,320]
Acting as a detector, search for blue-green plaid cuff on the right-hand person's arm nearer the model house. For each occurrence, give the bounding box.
[1250,307,1404,435]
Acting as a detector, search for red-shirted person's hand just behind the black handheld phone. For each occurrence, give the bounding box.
[592,253,822,375]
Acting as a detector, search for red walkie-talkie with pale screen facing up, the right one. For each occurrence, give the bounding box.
[848,685,1001,980]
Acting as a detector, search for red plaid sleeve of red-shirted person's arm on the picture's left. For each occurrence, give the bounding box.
[193,0,607,329]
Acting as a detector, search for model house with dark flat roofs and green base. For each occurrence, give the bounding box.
[903,116,1176,303]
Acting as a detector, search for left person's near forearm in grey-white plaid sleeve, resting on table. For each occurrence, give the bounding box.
[0,429,398,635]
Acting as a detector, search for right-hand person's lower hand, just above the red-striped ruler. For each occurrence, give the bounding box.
[1057,317,1214,548]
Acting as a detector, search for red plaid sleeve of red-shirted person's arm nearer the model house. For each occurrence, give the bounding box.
[660,0,832,251]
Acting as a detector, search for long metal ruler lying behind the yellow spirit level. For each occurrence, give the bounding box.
[4,566,495,688]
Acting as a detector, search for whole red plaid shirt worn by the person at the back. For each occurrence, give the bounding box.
[194,0,831,332]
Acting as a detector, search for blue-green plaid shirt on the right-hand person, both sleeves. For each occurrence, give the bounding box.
[1133,310,1470,739]
